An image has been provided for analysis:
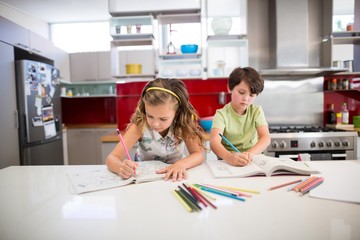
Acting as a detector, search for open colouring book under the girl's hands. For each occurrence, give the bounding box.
[67,161,169,194]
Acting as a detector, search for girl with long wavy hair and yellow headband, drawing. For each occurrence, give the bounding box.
[106,78,205,181]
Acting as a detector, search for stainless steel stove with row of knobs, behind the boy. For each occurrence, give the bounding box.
[264,125,358,160]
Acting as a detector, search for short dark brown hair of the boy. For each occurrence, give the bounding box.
[228,67,264,95]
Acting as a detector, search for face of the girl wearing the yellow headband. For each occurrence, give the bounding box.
[145,101,176,137]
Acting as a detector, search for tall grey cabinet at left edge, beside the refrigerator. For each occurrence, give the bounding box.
[0,42,20,169]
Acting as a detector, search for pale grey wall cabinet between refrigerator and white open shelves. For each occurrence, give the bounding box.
[70,51,112,82]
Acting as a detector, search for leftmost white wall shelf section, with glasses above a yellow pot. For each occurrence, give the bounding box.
[110,15,155,78]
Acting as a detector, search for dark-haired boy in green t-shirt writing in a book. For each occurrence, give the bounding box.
[210,67,270,166]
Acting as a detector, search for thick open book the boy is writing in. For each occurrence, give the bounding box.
[207,154,319,178]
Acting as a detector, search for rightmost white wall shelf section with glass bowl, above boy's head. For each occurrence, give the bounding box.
[205,0,249,78]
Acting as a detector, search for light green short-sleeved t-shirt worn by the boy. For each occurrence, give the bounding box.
[212,103,268,152]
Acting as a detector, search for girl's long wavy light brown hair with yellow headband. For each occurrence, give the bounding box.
[130,78,205,147]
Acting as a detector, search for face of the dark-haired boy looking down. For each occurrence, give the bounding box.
[228,81,257,115]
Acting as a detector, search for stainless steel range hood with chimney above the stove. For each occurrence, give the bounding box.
[260,0,347,76]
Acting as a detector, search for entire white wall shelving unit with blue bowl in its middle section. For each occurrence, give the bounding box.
[109,0,249,79]
